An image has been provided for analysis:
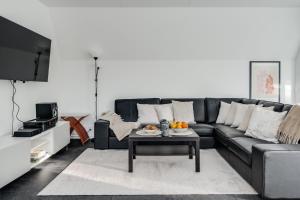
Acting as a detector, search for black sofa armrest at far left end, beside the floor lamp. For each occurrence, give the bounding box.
[94,119,110,149]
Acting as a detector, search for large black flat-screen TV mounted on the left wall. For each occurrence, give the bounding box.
[0,16,51,82]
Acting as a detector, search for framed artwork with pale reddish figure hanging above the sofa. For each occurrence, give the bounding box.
[250,61,280,102]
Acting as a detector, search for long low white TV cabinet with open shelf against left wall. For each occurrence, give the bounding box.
[0,121,70,188]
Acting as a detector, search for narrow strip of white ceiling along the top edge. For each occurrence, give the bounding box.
[40,0,300,7]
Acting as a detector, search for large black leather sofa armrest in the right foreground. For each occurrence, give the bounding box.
[252,144,300,199]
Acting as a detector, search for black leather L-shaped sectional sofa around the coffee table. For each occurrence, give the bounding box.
[95,98,300,199]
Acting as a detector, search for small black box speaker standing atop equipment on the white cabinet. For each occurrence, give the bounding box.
[36,103,58,119]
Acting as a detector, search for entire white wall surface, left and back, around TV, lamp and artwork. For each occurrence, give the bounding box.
[0,3,300,138]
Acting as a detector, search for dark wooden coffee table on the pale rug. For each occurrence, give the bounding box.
[128,129,200,172]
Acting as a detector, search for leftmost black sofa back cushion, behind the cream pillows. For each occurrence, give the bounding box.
[115,98,160,122]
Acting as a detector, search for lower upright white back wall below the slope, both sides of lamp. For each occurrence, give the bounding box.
[48,60,294,138]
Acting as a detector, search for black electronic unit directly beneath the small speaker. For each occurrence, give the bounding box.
[23,118,57,132]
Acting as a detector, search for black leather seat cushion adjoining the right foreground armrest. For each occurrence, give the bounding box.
[228,137,271,165]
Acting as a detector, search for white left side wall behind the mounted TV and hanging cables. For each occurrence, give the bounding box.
[0,0,56,135]
